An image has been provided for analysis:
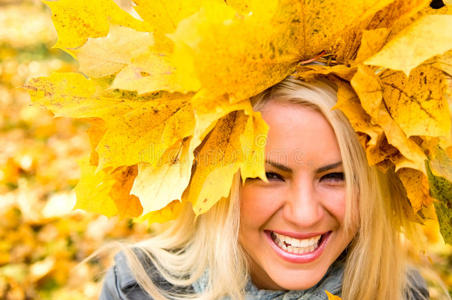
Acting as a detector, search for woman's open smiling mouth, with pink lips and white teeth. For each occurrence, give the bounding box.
[265,231,331,263]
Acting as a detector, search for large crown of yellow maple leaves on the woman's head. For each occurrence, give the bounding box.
[23,0,452,246]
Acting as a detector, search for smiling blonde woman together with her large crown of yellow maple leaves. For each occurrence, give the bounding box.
[26,0,452,300]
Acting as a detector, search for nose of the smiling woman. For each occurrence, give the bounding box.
[283,180,325,228]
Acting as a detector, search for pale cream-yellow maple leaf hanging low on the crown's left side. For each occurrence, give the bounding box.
[131,138,193,215]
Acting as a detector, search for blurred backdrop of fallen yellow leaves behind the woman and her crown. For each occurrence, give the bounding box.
[0,0,452,300]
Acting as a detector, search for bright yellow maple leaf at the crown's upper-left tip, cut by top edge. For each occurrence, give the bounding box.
[45,0,150,49]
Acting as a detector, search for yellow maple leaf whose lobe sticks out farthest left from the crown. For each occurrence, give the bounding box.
[29,73,194,168]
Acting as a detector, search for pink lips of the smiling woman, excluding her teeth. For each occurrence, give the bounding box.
[265,230,331,264]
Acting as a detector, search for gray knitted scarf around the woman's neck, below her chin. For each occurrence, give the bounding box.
[193,262,344,300]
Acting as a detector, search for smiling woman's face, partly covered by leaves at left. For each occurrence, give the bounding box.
[239,101,356,290]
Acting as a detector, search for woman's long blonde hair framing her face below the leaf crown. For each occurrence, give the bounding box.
[108,77,420,300]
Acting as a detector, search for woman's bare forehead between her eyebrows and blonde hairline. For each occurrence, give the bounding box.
[262,100,341,165]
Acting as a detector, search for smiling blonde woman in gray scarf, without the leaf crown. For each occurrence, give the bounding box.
[101,78,428,300]
